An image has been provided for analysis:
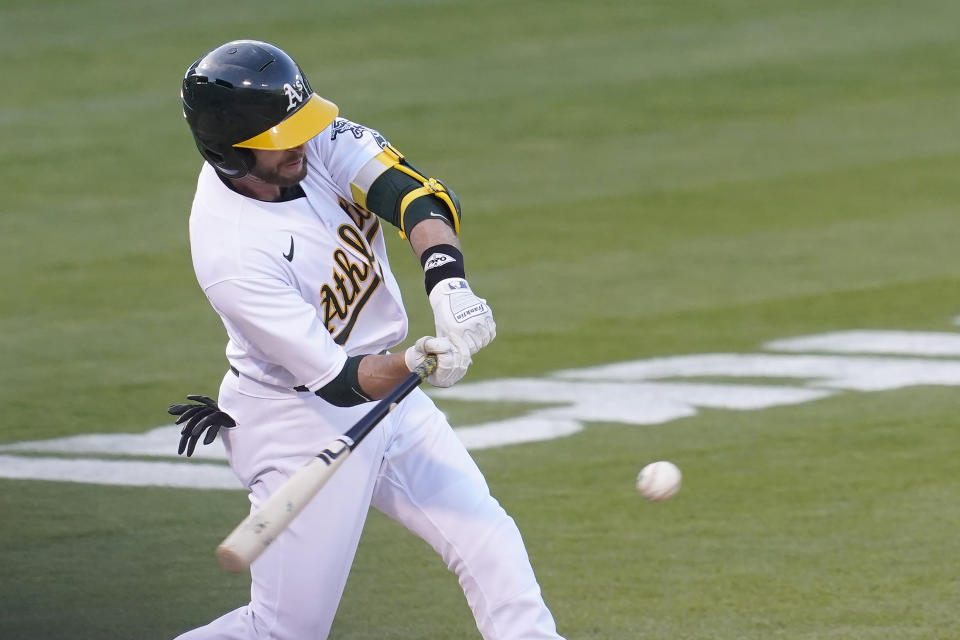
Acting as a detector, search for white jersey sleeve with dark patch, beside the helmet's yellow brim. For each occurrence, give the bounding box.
[315,118,391,201]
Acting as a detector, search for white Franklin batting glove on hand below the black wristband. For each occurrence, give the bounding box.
[430,278,497,355]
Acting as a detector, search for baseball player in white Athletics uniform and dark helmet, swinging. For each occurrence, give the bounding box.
[171,40,560,640]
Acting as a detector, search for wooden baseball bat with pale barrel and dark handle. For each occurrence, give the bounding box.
[216,355,437,573]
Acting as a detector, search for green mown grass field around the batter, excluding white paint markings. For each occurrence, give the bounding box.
[0,0,960,640]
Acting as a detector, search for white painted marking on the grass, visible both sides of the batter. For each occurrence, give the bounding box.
[0,330,960,489]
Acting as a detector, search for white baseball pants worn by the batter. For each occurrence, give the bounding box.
[178,373,560,640]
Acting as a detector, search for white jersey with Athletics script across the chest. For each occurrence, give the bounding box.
[190,118,407,391]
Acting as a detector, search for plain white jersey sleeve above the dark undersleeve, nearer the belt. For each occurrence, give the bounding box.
[204,278,347,391]
